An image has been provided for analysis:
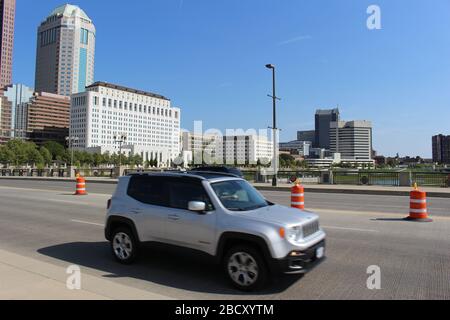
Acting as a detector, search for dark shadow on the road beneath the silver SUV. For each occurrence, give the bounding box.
[37,242,301,295]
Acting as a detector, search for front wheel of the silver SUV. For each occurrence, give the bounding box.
[222,245,269,292]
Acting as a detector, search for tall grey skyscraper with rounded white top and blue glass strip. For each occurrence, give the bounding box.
[35,4,96,96]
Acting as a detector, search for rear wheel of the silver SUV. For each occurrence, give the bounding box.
[110,227,139,264]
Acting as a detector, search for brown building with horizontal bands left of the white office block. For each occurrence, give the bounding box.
[27,92,70,145]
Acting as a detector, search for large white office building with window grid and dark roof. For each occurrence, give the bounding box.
[70,82,181,167]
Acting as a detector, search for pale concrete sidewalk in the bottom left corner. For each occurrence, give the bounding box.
[0,250,169,300]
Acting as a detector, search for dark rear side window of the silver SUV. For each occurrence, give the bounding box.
[128,176,168,206]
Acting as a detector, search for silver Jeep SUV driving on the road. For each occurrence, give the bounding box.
[105,172,325,291]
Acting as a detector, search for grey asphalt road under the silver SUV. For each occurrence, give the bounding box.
[0,180,450,300]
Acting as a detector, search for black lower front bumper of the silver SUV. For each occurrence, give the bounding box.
[271,240,326,274]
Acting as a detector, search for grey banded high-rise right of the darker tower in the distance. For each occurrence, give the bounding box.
[330,120,372,160]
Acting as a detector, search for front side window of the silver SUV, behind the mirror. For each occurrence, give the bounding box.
[168,180,214,211]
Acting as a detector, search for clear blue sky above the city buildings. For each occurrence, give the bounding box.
[9,0,450,158]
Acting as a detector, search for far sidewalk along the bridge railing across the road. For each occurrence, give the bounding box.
[0,176,450,198]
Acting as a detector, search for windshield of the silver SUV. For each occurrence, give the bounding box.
[211,180,269,211]
